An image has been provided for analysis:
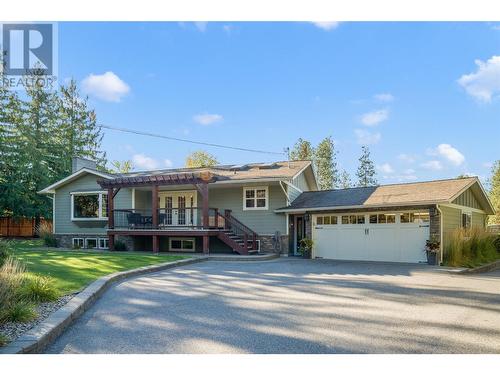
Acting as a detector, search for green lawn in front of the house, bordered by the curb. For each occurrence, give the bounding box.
[13,240,188,294]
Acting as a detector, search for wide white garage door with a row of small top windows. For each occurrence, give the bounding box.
[312,211,429,263]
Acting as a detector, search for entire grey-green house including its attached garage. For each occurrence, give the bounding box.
[40,158,494,263]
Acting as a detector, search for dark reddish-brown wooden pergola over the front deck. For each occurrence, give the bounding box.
[97,171,215,253]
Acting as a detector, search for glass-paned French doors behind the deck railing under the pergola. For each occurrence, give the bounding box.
[158,191,197,226]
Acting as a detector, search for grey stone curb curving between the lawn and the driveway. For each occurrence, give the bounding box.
[0,257,209,354]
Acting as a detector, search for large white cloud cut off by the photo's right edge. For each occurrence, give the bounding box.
[458,56,500,103]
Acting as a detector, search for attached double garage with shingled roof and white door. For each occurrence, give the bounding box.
[276,177,494,263]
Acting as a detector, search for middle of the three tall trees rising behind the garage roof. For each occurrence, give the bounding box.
[314,137,339,190]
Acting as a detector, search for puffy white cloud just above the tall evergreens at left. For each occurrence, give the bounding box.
[82,72,130,102]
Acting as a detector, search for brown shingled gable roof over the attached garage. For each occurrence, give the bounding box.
[276,177,494,214]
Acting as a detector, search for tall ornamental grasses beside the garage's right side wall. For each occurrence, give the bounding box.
[445,227,497,267]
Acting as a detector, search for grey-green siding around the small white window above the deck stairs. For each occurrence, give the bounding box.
[207,184,286,235]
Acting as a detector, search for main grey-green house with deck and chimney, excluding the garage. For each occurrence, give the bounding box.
[40,158,317,254]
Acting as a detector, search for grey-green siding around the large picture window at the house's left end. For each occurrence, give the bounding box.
[55,174,132,234]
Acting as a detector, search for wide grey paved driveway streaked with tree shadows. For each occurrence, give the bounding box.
[47,258,500,353]
